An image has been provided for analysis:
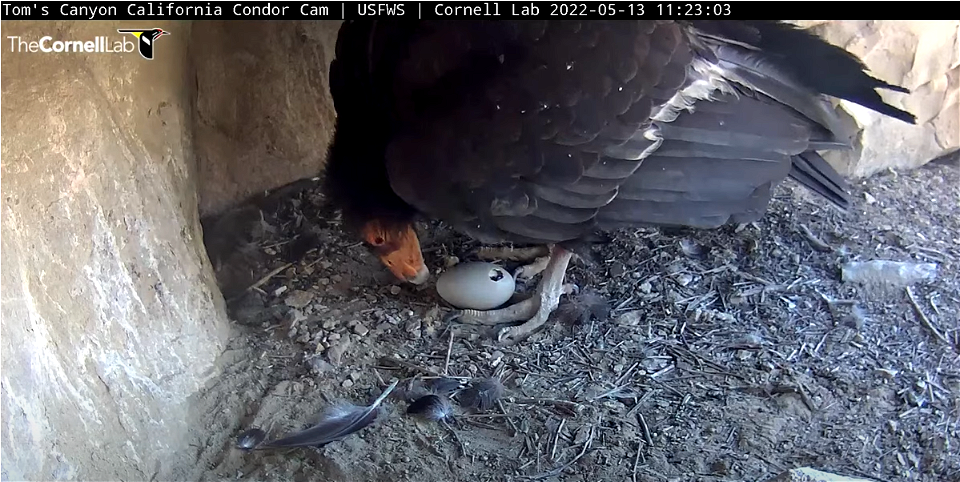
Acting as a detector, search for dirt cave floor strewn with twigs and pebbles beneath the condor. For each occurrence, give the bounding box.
[196,160,960,482]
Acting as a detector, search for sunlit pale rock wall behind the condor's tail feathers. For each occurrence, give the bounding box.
[795,20,960,176]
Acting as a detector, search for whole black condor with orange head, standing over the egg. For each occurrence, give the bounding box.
[327,21,914,342]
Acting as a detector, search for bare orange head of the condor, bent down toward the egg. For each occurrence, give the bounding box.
[360,219,430,285]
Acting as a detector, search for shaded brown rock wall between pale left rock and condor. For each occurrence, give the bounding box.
[191,21,340,216]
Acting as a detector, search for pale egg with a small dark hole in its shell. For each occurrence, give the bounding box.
[437,261,517,310]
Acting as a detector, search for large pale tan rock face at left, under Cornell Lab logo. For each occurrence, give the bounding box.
[0,21,228,480]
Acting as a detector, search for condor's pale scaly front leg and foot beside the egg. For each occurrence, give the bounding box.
[459,246,576,344]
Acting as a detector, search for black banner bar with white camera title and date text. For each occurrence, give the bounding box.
[0,0,949,22]
